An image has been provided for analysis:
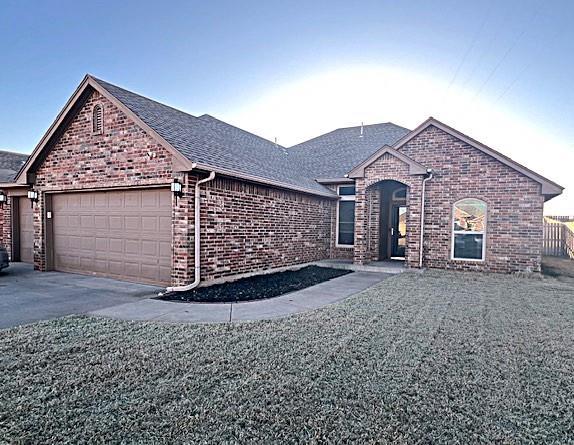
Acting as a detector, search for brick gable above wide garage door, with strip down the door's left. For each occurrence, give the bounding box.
[34,92,177,270]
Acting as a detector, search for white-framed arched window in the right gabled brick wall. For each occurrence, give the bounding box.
[451,198,486,261]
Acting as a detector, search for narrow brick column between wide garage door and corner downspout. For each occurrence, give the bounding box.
[171,173,196,286]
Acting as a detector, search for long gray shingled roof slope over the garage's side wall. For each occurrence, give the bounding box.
[94,78,332,194]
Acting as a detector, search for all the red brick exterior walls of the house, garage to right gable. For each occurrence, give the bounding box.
[0,85,544,285]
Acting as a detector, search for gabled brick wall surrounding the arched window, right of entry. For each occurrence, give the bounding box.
[401,126,544,273]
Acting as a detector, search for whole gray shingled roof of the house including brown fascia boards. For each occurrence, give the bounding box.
[11,75,562,199]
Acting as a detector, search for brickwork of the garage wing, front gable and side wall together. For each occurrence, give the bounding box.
[14,87,334,285]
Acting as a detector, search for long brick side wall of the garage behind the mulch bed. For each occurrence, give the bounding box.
[197,177,332,280]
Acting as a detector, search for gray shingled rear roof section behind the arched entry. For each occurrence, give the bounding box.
[288,122,410,179]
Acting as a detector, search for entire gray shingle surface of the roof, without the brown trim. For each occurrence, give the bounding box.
[94,78,409,194]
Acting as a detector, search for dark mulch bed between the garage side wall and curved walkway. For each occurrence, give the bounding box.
[158,266,351,303]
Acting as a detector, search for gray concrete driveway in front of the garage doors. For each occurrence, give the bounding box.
[0,263,160,329]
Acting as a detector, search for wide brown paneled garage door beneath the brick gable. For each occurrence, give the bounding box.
[52,189,171,284]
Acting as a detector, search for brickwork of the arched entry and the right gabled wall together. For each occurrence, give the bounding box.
[344,126,544,273]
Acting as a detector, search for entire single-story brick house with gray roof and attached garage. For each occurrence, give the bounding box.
[1,76,562,285]
